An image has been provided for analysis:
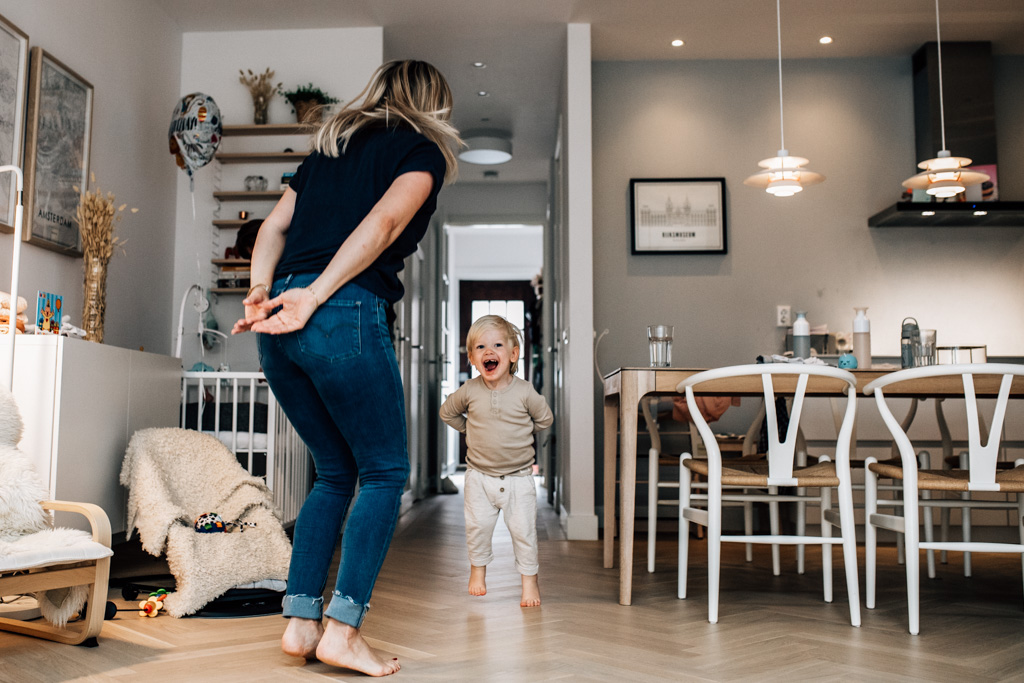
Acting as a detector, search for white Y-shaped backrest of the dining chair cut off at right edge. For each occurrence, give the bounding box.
[864,362,1024,490]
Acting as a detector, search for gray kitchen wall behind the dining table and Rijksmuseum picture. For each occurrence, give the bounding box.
[594,56,1024,485]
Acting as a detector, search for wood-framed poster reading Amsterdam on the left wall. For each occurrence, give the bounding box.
[23,47,92,256]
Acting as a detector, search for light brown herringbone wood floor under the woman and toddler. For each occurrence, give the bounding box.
[0,481,1024,683]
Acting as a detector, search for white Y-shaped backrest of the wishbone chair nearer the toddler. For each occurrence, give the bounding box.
[676,364,857,486]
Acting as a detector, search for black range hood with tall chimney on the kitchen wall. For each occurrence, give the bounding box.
[867,41,1024,227]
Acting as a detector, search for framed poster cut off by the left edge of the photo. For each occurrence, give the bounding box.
[0,10,29,232]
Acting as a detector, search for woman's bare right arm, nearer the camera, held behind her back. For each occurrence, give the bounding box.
[251,171,434,334]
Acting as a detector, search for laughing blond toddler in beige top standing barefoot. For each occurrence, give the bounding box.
[440,315,554,607]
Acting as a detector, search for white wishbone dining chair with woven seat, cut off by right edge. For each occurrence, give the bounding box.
[864,364,1024,635]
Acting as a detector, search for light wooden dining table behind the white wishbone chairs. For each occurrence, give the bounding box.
[603,368,1024,605]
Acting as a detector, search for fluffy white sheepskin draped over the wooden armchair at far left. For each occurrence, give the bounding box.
[0,387,105,628]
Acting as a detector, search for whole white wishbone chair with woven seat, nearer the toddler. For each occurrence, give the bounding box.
[678,364,860,626]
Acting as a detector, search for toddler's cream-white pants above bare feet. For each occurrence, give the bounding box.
[465,469,539,577]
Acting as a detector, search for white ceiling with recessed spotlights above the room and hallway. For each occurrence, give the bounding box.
[160,0,1024,182]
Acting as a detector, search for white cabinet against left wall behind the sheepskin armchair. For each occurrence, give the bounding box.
[14,335,181,533]
